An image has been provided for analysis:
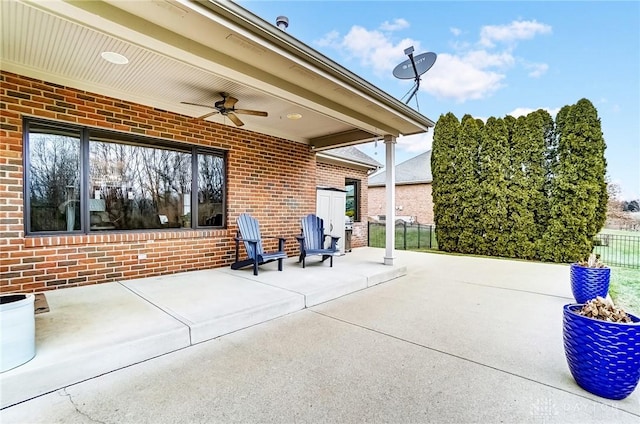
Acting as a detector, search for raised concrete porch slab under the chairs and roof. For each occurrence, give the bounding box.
[0,250,406,408]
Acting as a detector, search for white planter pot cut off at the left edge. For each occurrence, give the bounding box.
[0,293,36,372]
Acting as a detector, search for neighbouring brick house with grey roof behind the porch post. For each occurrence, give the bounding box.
[368,150,434,224]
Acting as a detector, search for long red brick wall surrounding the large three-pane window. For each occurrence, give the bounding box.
[0,72,318,292]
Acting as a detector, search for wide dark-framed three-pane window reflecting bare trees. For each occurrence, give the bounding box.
[25,121,226,233]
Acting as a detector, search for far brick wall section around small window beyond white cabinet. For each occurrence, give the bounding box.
[316,162,369,248]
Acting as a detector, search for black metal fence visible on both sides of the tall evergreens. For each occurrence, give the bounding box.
[368,221,640,268]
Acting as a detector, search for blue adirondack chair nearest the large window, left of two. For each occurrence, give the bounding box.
[231,213,287,275]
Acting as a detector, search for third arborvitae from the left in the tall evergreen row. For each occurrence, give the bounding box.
[475,118,509,256]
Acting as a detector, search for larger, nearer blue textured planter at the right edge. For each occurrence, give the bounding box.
[562,304,640,400]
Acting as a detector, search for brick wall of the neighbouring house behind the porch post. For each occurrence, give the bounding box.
[368,184,434,224]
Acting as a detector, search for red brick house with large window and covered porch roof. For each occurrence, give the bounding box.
[0,0,433,292]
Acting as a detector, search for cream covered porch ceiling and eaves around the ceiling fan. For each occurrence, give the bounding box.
[0,0,434,150]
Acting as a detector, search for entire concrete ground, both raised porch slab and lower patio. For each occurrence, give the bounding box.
[0,248,640,424]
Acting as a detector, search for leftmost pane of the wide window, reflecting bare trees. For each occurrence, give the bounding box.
[29,130,80,231]
